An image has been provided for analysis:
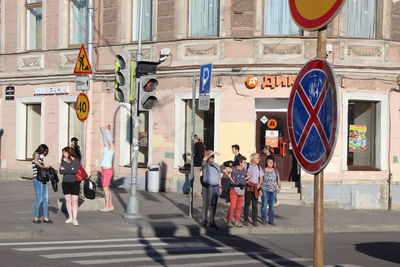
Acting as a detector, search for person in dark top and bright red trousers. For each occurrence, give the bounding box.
[223,156,251,227]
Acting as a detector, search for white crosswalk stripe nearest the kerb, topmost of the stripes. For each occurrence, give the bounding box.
[0,237,178,246]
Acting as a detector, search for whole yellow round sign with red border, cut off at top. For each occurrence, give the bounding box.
[289,0,344,31]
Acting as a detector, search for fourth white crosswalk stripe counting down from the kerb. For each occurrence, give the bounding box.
[72,251,280,265]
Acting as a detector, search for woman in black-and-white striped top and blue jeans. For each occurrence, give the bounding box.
[32,144,53,223]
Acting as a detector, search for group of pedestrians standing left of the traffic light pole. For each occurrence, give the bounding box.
[32,125,114,226]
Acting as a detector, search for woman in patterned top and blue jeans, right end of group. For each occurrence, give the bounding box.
[261,156,281,226]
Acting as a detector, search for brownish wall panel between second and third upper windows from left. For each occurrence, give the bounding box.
[100,0,120,44]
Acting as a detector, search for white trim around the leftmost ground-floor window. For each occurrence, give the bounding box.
[15,97,46,160]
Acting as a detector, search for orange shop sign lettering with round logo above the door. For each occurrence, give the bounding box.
[245,75,296,89]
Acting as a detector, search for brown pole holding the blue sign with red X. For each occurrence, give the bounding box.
[314,26,327,267]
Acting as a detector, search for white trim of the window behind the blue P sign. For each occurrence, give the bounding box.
[174,92,221,169]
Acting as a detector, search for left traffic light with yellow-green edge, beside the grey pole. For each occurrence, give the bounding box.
[114,53,133,103]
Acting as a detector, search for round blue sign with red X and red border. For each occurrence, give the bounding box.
[288,58,339,174]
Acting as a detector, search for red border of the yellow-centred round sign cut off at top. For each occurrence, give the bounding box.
[289,0,344,30]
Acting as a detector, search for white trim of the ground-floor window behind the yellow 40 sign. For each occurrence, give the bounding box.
[58,96,76,160]
